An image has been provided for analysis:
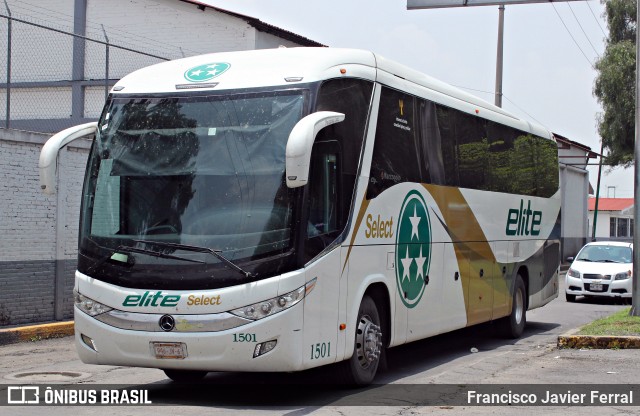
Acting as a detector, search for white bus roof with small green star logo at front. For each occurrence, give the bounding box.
[111,47,551,138]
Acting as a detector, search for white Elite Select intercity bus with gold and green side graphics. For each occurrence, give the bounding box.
[40,48,560,384]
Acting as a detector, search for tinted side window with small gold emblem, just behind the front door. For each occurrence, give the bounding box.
[367,88,422,199]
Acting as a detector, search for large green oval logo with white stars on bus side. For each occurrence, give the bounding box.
[396,191,431,308]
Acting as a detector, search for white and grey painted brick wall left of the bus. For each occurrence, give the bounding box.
[0,130,89,327]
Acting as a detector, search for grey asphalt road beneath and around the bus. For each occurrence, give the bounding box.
[0,274,640,416]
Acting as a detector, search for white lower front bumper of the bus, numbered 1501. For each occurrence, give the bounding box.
[74,301,304,371]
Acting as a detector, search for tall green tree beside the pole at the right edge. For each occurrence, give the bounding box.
[593,0,637,167]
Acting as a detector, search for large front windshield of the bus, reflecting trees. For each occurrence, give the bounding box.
[79,91,305,288]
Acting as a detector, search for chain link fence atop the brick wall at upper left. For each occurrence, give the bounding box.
[0,1,184,133]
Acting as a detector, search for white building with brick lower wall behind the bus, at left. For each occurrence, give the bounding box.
[0,0,323,327]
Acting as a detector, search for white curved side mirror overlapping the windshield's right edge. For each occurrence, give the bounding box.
[285,111,344,188]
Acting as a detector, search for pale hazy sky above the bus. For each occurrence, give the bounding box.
[208,0,634,198]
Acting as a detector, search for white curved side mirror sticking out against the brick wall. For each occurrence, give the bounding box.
[38,122,98,195]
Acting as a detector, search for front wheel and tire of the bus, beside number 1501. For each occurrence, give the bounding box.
[340,295,383,386]
